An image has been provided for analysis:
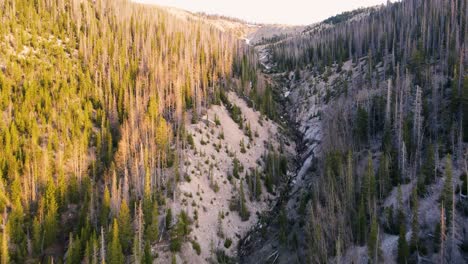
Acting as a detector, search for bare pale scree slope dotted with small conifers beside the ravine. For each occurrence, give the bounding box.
[158,92,294,263]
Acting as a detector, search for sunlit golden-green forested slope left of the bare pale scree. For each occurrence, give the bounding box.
[0,0,274,263]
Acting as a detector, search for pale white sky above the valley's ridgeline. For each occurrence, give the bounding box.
[132,0,387,25]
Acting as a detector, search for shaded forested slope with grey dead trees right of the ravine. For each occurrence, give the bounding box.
[249,0,468,263]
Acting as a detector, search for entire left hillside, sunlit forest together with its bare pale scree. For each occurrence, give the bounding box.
[0,0,289,263]
